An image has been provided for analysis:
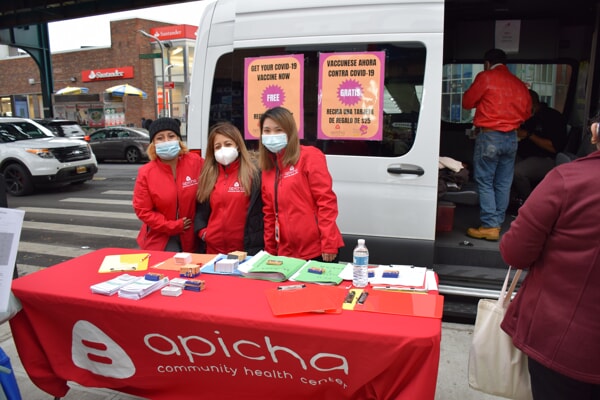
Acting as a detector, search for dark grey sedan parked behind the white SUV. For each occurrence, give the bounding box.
[90,126,150,163]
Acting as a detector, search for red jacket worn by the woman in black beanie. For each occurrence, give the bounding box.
[133,153,204,252]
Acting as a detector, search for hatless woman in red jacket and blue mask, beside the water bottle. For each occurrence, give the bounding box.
[258,107,344,262]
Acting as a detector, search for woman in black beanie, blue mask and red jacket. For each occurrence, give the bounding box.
[133,118,203,252]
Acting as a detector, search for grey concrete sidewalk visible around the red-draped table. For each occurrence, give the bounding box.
[0,323,501,400]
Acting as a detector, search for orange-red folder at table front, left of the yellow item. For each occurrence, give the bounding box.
[266,285,346,316]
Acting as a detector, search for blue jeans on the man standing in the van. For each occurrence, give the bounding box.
[473,131,517,228]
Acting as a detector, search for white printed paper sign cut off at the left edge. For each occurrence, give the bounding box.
[0,207,25,312]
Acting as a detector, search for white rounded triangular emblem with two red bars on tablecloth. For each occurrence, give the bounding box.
[71,321,135,379]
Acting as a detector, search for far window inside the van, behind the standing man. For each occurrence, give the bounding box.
[442,63,573,123]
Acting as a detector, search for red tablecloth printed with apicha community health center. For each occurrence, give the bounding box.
[10,248,441,400]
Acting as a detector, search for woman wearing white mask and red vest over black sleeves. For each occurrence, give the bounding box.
[194,122,264,255]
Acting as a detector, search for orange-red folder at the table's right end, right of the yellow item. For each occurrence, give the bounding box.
[354,290,444,318]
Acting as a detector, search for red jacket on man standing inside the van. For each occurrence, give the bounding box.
[463,64,531,132]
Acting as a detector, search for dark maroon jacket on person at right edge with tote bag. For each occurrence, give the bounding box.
[500,151,600,385]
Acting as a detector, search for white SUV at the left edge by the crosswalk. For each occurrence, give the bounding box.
[0,118,98,196]
